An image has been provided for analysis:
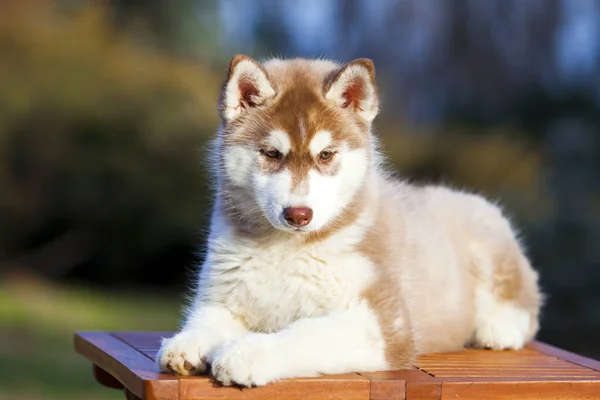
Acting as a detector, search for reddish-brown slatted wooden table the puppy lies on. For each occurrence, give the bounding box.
[75,332,600,400]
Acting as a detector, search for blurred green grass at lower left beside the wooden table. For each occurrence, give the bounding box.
[0,279,183,400]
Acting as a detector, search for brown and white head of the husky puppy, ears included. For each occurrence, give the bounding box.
[217,55,379,232]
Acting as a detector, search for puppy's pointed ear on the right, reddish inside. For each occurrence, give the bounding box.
[325,58,379,122]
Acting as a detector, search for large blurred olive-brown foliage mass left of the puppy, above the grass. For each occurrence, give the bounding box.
[0,1,221,276]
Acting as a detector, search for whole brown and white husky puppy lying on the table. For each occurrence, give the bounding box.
[157,55,542,387]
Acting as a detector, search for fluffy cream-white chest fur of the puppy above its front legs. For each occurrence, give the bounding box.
[211,247,373,332]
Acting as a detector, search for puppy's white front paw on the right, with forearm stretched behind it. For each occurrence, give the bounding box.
[212,334,280,387]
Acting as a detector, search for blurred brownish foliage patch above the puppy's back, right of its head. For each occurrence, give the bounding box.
[378,120,553,226]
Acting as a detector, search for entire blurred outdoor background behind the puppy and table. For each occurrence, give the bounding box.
[0,0,600,399]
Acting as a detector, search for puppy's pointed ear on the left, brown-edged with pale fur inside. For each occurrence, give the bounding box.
[219,54,275,121]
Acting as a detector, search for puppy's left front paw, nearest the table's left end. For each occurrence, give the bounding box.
[156,331,210,375]
